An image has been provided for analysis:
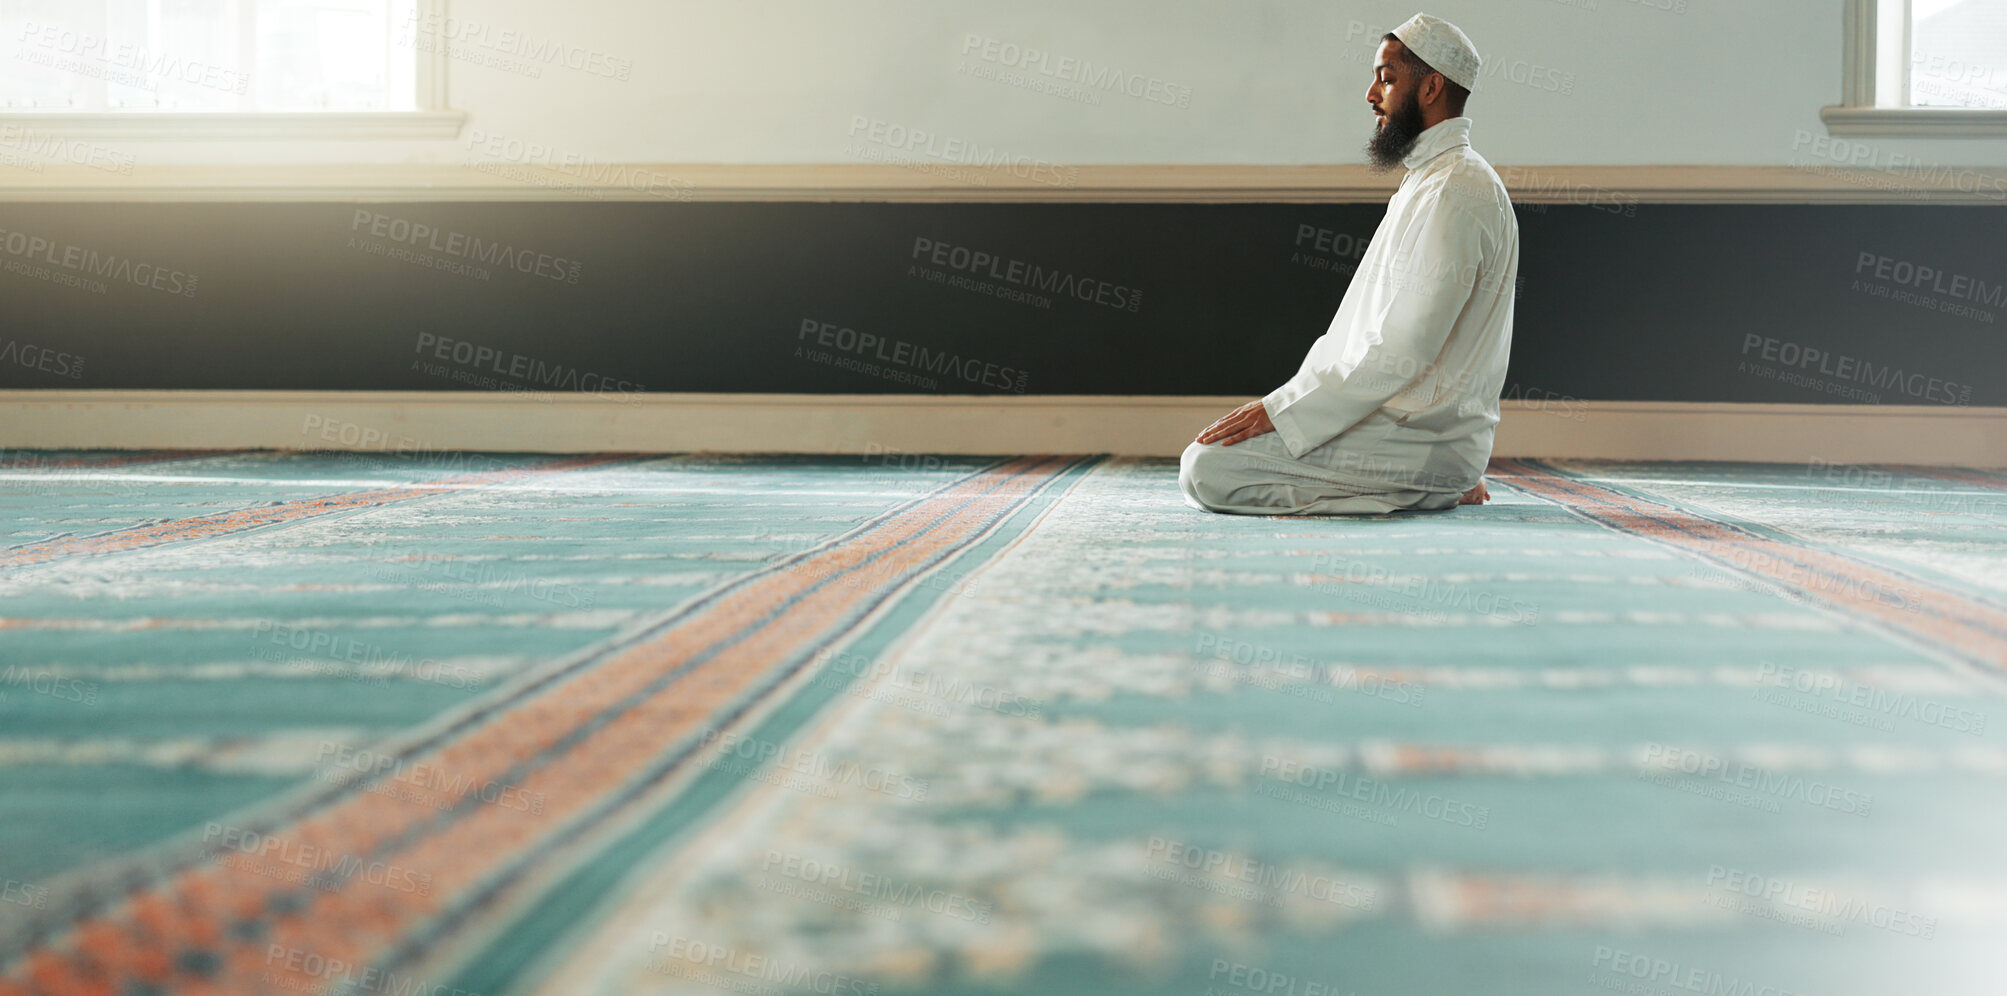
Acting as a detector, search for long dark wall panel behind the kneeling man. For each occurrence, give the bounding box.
[0,203,2007,406]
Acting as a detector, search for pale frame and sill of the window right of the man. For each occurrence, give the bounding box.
[1818,0,2007,139]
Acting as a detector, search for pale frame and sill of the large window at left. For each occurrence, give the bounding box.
[0,0,468,139]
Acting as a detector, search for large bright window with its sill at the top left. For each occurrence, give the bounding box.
[0,0,462,137]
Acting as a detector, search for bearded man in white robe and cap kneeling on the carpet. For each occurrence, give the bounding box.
[1178,14,1519,514]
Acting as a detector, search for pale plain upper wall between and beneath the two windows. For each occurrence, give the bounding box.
[15,0,2007,167]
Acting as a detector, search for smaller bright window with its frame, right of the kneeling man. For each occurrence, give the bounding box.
[1822,0,2007,137]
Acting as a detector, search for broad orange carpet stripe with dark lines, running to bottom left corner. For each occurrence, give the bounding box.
[3,458,1074,994]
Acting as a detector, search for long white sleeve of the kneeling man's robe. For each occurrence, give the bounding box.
[1262,195,1483,458]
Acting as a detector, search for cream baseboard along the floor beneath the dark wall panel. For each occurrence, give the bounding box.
[0,390,2007,468]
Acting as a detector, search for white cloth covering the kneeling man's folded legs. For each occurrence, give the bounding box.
[1178,432,1475,516]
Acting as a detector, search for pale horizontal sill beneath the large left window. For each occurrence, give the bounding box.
[0,110,468,139]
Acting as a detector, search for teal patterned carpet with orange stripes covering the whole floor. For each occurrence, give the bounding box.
[0,452,2007,996]
